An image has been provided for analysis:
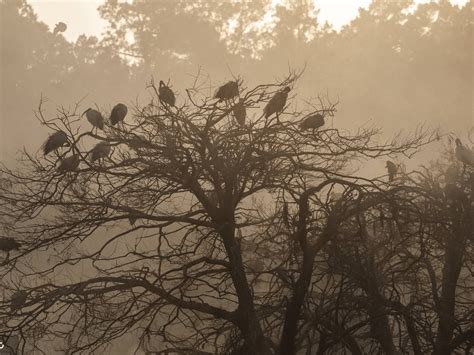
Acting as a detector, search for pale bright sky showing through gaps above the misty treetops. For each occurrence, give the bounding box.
[28,0,468,41]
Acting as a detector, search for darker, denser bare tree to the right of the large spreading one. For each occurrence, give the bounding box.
[294,150,474,354]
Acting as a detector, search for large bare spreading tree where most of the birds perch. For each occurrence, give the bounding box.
[0,74,436,354]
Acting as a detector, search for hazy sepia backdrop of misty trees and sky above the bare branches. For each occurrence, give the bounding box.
[0,0,474,161]
